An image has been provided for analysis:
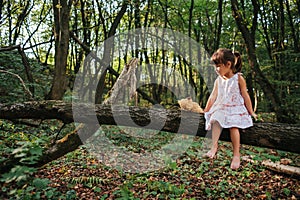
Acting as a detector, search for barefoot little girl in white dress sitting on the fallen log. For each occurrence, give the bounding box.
[204,48,257,169]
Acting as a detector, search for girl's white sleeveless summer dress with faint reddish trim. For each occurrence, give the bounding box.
[205,73,253,130]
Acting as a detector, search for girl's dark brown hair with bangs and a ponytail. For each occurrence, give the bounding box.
[211,48,242,74]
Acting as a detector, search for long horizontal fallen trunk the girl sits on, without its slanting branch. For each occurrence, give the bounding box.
[0,101,300,153]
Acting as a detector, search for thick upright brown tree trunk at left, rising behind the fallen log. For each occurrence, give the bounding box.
[48,0,70,100]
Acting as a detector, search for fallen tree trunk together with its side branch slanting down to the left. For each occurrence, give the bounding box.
[0,101,300,173]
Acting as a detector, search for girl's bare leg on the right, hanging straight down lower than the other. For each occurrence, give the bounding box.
[230,128,241,169]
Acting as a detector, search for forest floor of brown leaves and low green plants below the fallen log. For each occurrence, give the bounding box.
[0,124,300,199]
